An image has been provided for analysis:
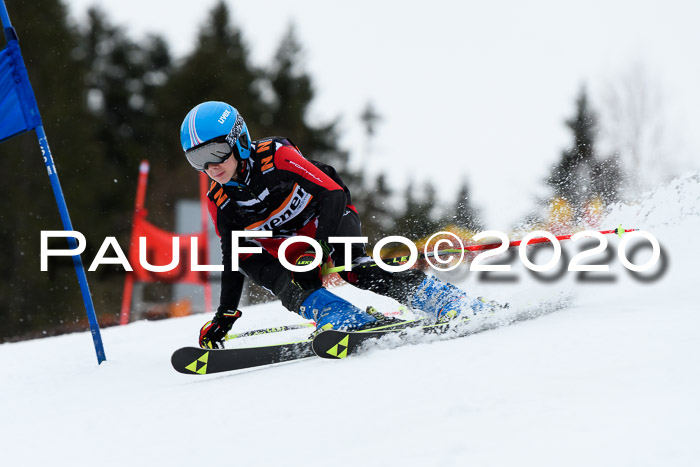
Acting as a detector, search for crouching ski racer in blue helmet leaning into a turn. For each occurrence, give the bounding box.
[180,101,484,348]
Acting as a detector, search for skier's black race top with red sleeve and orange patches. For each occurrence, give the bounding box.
[207,137,356,310]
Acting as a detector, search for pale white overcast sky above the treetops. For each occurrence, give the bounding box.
[64,0,700,231]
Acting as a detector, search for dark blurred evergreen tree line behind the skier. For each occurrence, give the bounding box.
[0,0,486,341]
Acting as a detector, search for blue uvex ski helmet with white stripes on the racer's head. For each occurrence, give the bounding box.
[180,101,251,170]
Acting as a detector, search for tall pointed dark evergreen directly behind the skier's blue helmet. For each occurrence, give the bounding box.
[148,1,265,228]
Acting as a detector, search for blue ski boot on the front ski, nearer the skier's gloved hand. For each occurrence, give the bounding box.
[299,288,381,332]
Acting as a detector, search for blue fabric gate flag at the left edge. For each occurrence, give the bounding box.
[0,40,41,143]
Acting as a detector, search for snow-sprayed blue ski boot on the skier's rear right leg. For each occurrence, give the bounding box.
[411,276,498,322]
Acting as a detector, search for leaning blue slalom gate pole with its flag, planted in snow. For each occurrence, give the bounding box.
[0,0,106,364]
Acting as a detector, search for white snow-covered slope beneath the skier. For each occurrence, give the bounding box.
[0,175,700,466]
